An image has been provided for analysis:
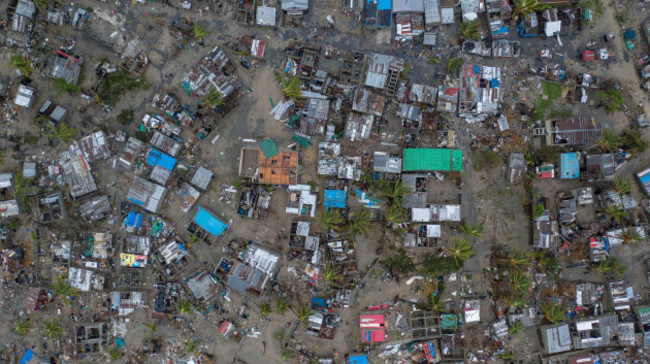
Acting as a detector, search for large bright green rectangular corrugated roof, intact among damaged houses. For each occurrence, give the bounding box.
[402,148,463,172]
